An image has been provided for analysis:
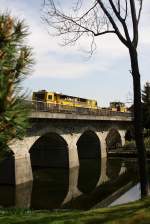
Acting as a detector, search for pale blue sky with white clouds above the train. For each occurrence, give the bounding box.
[0,0,150,107]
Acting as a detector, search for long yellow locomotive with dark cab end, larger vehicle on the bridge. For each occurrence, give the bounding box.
[32,90,98,109]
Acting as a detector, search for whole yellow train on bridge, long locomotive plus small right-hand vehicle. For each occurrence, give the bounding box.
[32,90,127,112]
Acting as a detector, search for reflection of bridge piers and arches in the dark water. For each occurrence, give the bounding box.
[0,155,138,209]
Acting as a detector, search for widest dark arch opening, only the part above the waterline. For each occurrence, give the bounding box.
[29,132,69,167]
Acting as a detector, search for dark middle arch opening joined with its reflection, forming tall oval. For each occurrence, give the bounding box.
[77,130,101,193]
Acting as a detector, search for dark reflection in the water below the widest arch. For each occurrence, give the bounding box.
[31,168,69,209]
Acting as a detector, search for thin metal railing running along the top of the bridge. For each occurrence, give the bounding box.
[25,101,132,117]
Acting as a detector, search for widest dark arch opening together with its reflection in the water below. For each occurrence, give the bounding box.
[30,133,69,209]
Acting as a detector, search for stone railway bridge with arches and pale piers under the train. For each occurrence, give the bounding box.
[3,104,133,185]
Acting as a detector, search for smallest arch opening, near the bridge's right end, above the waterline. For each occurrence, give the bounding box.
[106,129,122,150]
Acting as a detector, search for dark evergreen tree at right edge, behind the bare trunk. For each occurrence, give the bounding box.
[142,82,150,129]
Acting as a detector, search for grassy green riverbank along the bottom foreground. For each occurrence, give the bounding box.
[0,198,150,224]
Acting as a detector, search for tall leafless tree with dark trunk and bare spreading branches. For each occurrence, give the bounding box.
[43,0,148,198]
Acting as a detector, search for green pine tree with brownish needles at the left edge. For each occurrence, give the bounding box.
[0,13,33,151]
